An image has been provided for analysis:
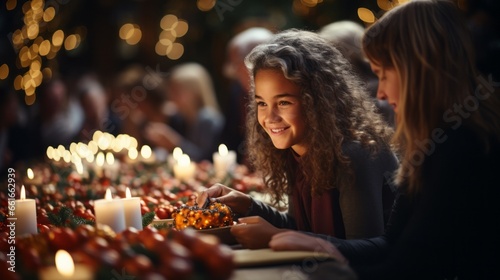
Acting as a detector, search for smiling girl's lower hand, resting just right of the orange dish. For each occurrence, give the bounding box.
[231,216,284,249]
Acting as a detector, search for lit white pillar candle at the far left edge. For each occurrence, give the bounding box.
[15,185,38,236]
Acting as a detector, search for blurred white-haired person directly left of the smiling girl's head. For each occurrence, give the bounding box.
[223,27,273,163]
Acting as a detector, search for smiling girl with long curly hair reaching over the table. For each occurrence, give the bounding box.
[199,30,397,248]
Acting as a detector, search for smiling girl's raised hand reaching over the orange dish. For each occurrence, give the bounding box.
[196,183,252,215]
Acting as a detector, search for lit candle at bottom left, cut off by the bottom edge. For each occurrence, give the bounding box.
[38,250,94,280]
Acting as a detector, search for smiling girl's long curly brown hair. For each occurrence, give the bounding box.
[245,29,392,202]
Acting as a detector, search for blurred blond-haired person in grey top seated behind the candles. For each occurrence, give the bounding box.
[144,62,225,161]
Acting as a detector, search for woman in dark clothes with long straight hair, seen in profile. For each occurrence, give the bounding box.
[270,0,500,279]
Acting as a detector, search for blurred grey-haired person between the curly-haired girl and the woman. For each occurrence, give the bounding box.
[318,20,394,127]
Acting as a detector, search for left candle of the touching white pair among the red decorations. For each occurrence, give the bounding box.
[94,189,126,233]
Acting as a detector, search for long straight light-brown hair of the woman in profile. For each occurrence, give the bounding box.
[362,0,499,192]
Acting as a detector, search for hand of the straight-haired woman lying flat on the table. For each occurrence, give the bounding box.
[269,230,348,264]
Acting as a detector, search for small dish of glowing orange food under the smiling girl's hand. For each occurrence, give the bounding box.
[172,202,238,245]
